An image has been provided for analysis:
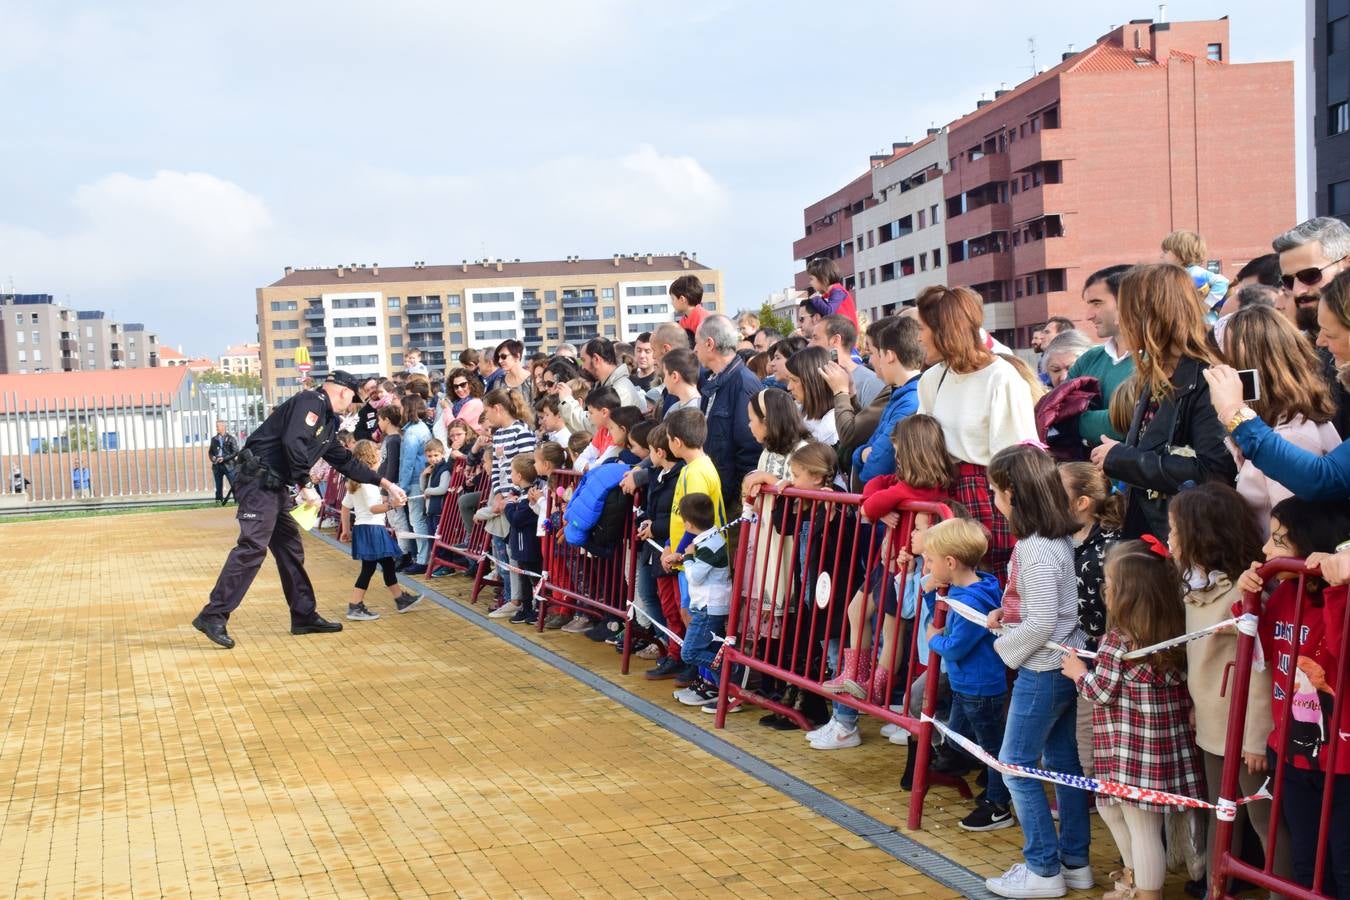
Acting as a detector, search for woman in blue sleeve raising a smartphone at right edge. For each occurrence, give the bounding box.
[1204,271,1350,501]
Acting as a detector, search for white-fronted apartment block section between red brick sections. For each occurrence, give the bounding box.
[852,128,948,321]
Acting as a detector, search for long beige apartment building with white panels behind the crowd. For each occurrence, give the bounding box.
[258,254,726,387]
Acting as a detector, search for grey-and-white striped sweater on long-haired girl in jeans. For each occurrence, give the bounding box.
[994,534,1087,672]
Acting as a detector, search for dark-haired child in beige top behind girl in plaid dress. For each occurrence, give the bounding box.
[1166,482,1289,890]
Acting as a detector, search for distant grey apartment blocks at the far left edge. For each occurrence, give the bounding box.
[0,294,159,375]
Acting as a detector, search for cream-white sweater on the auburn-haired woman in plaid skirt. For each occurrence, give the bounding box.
[919,359,1037,466]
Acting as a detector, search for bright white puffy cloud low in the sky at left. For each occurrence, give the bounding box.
[0,170,274,290]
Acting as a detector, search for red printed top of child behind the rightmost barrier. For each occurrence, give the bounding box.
[1258,579,1350,775]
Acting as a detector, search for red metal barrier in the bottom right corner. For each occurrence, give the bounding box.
[1210,559,1350,900]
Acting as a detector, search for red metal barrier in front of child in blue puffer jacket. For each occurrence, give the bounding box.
[537,470,639,675]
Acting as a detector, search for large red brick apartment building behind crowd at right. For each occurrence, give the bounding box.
[794,19,1295,347]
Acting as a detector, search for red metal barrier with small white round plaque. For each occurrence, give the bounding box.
[716,487,971,828]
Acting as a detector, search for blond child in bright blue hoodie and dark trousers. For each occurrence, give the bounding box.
[923,518,1013,831]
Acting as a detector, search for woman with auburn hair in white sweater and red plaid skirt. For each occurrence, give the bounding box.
[918,285,1037,580]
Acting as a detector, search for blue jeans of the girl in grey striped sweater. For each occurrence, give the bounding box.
[999,667,1089,878]
